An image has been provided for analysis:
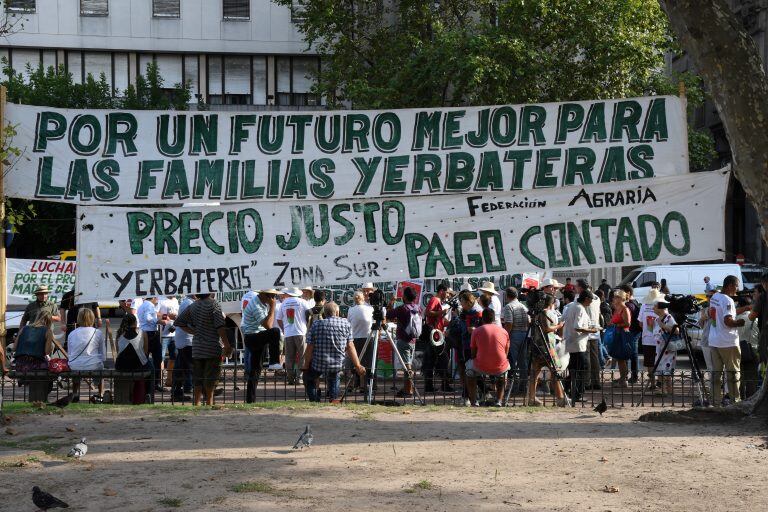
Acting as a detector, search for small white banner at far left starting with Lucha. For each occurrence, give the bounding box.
[6,258,77,306]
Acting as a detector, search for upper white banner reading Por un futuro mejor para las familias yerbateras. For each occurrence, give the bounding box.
[5,96,688,205]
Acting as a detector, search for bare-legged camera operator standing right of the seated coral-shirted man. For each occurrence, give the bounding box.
[527,295,569,407]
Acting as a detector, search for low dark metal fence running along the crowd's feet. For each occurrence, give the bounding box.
[0,364,761,408]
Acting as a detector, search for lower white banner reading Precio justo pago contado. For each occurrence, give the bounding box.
[77,172,728,301]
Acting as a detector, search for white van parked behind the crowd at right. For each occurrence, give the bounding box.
[621,263,744,300]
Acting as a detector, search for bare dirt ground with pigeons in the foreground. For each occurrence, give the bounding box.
[0,406,768,512]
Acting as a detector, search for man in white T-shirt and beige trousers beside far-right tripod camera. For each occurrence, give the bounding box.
[709,276,750,405]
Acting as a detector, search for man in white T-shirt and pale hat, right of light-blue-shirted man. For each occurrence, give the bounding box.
[275,288,310,384]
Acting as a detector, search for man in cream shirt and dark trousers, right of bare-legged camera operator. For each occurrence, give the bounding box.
[563,291,597,402]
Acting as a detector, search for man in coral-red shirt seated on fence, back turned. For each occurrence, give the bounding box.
[467,308,509,407]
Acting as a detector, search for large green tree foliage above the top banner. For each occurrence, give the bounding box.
[274,0,671,108]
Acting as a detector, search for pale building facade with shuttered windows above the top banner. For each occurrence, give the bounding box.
[0,0,322,110]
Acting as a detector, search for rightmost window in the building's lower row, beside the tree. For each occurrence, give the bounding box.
[275,57,320,106]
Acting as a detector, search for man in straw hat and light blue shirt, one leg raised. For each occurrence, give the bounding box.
[240,288,280,403]
